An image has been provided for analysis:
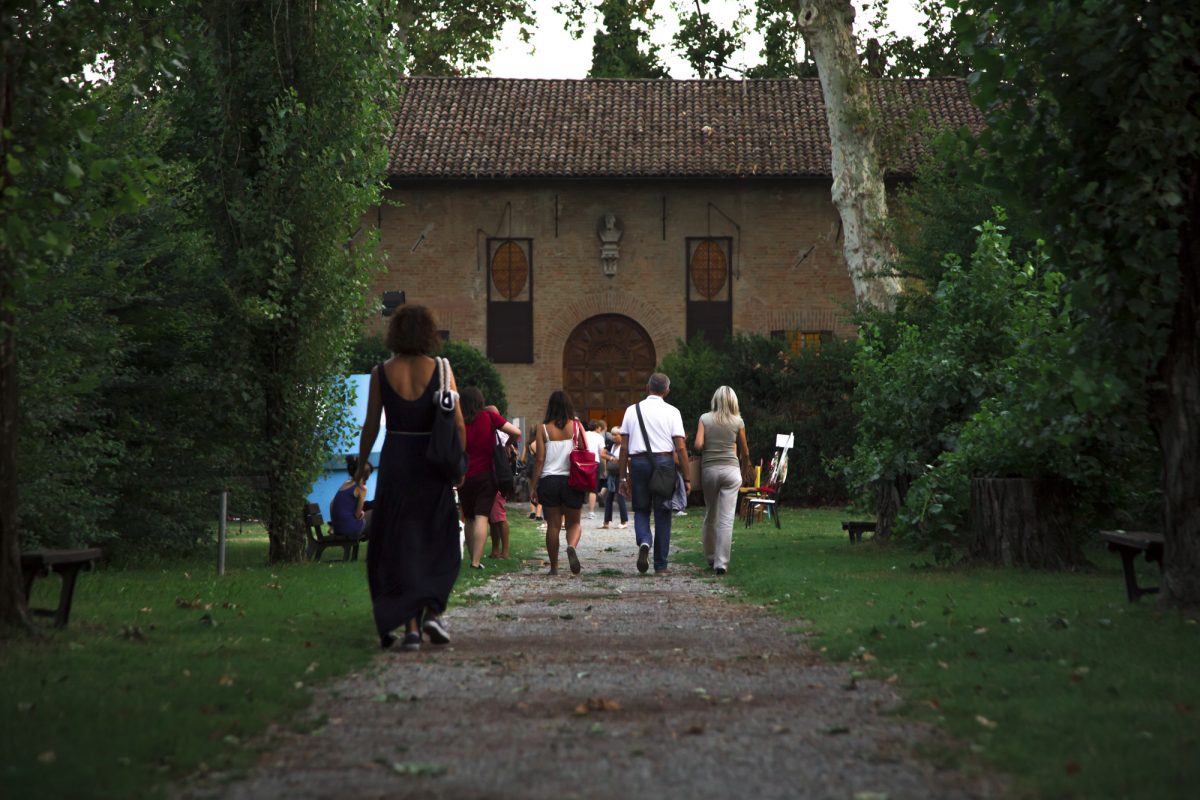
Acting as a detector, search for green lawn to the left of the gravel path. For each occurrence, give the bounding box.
[0,515,541,798]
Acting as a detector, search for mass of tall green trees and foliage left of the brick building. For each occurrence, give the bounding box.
[0,0,530,559]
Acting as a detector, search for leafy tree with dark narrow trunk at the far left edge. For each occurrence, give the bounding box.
[0,0,162,626]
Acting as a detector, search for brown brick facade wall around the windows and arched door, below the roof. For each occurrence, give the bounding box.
[371,180,854,419]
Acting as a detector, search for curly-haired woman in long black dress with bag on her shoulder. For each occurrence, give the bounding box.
[359,306,467,650]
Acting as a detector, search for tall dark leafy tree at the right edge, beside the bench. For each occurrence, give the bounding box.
[948,0,1200,608]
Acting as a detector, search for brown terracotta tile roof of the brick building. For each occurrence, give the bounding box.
[388,78,983,180]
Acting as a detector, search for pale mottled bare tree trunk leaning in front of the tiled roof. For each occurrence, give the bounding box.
[797,0,900,309]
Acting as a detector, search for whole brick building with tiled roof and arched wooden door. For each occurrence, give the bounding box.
[372,78,982,423]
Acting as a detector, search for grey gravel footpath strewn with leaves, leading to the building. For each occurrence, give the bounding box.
[179,510,1002,800]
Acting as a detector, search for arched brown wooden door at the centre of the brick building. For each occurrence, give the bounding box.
[563,314,656,428]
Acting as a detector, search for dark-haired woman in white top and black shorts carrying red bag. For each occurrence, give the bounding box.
[529,389,583,575]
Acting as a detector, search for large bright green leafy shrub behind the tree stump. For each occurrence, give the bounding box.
[845,223,1153,553]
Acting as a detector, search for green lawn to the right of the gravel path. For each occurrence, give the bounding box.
[679,510,1200,799]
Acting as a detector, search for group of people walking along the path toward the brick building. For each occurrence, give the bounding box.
[343,306,750,650]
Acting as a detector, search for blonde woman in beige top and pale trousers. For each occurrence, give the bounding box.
[695,386,750,575]
